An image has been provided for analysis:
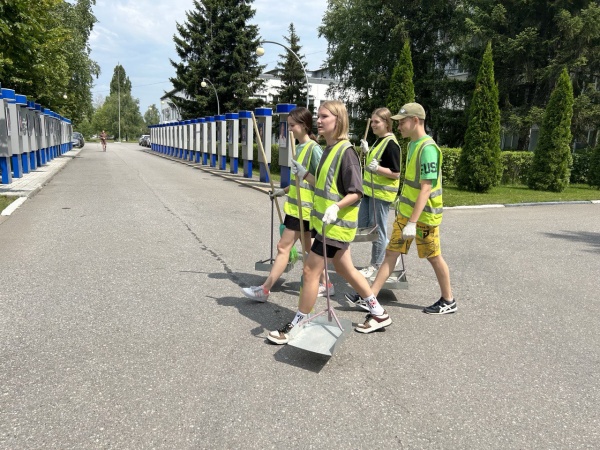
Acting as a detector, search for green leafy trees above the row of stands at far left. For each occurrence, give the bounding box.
[0,0,99,127]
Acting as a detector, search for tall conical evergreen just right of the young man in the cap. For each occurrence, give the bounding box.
[457,42,502,192]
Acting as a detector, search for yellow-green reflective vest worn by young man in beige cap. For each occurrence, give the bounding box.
[398,138,443,226]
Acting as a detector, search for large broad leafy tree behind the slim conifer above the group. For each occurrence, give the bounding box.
[319,0,465,145]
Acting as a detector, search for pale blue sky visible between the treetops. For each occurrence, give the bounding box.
[90,0,327,115]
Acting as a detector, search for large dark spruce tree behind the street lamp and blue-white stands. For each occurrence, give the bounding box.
[170,0,263,119]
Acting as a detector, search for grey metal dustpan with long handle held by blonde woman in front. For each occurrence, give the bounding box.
[288,224,352,356]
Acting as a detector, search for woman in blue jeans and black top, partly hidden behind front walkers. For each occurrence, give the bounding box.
[358,108,402,278]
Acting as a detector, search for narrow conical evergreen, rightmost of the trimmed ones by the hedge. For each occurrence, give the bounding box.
[528,68,573,192]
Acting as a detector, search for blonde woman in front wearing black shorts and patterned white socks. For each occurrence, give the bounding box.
[267,100,392,344]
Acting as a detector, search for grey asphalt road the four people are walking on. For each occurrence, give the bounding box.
[0,144,600,449]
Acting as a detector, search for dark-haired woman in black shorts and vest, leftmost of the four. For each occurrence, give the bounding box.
[242,107,323,302]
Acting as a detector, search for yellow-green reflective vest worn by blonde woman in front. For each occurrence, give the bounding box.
[310,140,360,242]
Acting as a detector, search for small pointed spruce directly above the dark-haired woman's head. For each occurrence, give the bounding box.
[277,23,307,106]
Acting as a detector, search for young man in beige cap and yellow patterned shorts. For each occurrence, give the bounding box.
[346,103,457,314]
